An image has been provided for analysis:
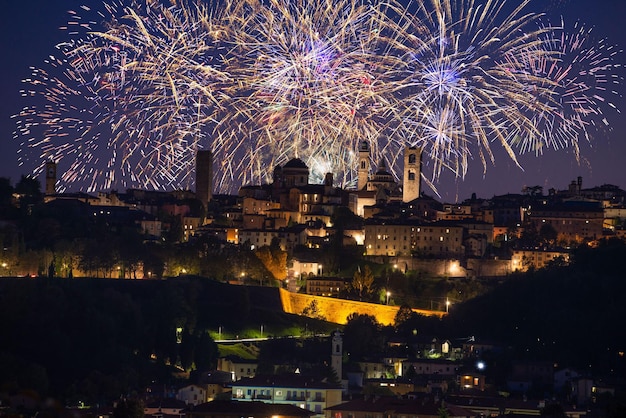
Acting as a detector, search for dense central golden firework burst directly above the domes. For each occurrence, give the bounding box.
[227,0,399,186]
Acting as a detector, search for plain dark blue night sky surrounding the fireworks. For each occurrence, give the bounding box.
[0,0,626,202]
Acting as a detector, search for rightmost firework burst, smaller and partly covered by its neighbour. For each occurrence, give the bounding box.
[507,18,620,159]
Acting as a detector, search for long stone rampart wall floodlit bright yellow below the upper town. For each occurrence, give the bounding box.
[279,289,445,325]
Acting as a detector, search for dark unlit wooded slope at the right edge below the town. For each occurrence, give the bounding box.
[445,240,626,372]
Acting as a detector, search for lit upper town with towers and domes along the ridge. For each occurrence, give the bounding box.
[3,144,626,280]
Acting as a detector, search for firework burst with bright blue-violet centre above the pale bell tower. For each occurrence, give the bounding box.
[394,0,550,183]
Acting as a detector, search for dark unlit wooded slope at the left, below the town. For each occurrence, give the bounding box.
[0,278,336,401]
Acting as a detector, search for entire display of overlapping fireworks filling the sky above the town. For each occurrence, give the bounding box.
[16,0,619,193]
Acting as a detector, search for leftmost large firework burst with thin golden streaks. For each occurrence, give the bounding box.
[19,2,234,191]
